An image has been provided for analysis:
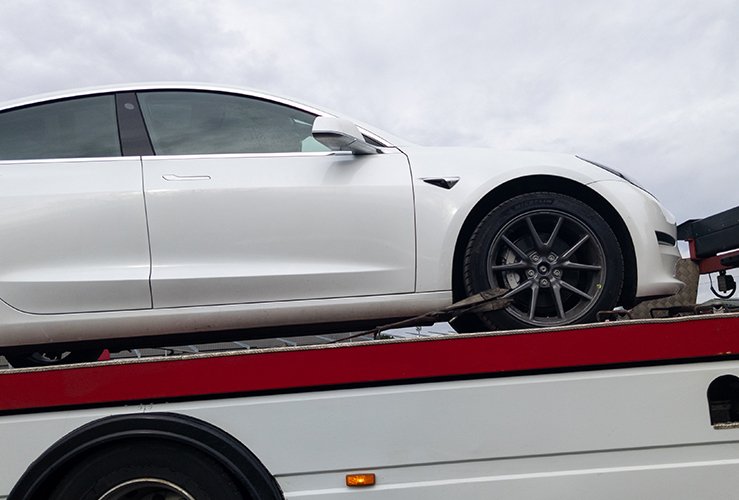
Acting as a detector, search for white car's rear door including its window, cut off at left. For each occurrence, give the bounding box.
[0,95,151,313]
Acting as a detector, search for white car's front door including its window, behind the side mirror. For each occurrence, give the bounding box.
[138,91,415,307]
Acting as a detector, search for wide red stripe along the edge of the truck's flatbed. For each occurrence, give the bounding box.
[0,315,739,413]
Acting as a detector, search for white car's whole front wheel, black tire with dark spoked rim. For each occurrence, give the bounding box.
[452,192,624,332]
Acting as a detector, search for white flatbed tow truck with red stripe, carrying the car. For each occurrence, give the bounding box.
[0,205,739,500]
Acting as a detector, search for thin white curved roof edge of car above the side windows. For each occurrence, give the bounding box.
[0,81,411,145]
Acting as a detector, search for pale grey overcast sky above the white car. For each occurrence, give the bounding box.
[0,0,739,298]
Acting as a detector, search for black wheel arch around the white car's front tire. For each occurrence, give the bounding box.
[452,175,637,307]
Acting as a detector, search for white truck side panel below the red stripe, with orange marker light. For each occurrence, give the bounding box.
[0,361,739,500]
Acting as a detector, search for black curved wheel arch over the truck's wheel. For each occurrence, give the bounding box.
[8,413,284,500]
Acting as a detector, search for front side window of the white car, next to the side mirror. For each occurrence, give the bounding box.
[138,90,328,155]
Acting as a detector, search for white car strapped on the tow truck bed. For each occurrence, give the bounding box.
[0,84,682,365]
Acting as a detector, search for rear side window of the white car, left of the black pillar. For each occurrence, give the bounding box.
[0,95,121,160]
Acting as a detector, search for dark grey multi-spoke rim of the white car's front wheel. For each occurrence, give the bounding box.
[486,210,606,326]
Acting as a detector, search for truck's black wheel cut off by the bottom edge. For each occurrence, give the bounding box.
[49,441,247,500]
